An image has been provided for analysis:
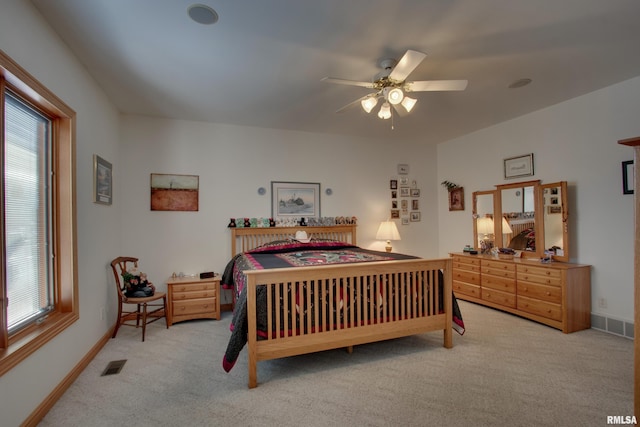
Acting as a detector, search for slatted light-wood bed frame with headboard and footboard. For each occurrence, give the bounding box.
[230,225,453,388]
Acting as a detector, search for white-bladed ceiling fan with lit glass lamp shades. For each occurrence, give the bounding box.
[322,50,468,120]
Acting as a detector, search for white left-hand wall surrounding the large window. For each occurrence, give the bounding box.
[0,0,121,426]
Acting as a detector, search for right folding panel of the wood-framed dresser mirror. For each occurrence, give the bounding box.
[540,181,569,262]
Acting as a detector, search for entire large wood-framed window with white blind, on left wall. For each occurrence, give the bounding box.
[0,51,79,375]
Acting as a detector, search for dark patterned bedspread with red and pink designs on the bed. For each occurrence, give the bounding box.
[221,239,464,372]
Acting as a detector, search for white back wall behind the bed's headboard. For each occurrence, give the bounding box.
[119,116,438,306]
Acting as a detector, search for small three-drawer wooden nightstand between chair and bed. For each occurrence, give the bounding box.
[167,275,220,326]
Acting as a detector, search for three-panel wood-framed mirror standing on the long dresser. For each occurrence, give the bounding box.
[473,181,569,262]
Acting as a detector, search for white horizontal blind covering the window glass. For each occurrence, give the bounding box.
[3,92,55,333]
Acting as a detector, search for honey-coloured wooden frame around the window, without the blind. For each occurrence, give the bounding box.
[0,50,80,376]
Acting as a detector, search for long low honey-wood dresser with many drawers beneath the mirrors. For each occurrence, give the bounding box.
[451,253,591,333]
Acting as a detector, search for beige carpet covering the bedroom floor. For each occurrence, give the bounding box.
[41,301,633,427]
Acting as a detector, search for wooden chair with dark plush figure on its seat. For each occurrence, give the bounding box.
[111,257,169,341]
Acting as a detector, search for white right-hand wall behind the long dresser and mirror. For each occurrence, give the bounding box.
[438,77,640,323]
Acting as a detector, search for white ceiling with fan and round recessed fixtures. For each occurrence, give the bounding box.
[32,0,640,143]
